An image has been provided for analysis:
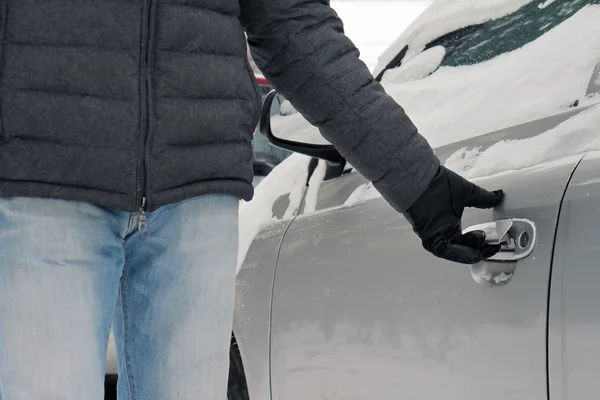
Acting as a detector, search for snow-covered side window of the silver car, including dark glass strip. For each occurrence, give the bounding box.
[381,0,600,147]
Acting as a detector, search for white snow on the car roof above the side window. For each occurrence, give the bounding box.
[374,0,531,75]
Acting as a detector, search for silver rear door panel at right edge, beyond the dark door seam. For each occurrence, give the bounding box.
[548,151,600,400]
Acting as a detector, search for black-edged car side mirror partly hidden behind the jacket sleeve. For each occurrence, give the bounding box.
[259,90,345,164]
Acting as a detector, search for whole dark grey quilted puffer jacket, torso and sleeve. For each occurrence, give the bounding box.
[0,0,438,212]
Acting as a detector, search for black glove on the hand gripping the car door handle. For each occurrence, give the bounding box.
[404,167,504,264]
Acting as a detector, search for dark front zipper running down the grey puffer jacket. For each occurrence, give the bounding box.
[137,0,154,232]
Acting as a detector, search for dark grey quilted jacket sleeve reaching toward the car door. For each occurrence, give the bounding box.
[240,0,439,212]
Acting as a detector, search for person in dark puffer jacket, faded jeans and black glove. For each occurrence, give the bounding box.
[0,0,502,400]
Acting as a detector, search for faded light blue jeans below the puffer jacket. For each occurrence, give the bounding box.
[0,195,238,400]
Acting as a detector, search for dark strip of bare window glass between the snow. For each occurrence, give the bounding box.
[426,0,600,66]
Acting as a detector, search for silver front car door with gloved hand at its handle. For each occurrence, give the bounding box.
[271,109,585,400]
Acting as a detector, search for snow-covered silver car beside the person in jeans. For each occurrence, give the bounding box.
[108,0,600,400]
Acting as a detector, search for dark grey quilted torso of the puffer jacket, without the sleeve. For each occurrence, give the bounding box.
[0,0,260,212]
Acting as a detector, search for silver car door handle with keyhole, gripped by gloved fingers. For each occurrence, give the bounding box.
[463,218,537,286]
